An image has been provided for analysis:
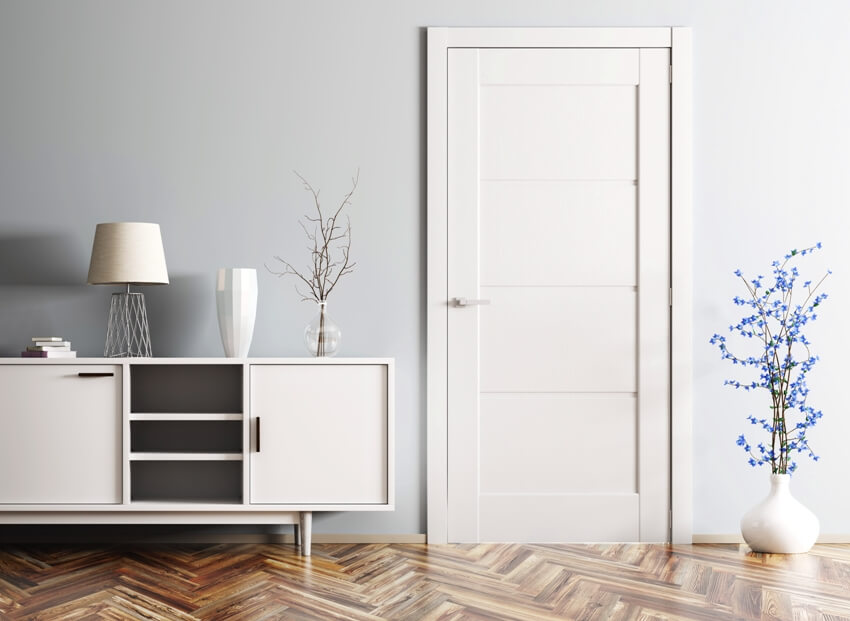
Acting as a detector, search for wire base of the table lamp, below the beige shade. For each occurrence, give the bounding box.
[103,287,153,358]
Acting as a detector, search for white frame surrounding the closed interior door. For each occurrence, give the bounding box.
[426,27,693,544]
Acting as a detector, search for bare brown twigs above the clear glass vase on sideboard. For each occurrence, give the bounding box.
[266,168,360,303]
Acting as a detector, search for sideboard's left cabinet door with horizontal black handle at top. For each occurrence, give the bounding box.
[0,364,122,504]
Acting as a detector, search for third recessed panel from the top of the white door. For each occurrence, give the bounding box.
[476,286,637,393]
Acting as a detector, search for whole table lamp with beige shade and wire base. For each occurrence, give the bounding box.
[88,222,168,358]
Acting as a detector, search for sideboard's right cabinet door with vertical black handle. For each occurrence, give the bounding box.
[250,364,387,504]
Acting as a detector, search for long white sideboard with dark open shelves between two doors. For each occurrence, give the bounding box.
[0,358,395,554]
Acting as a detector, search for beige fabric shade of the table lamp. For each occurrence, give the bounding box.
[88,222,168,285]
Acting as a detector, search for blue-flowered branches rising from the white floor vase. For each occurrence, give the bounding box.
[710,243,832,474]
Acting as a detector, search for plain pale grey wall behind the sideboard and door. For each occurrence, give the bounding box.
[0,0,850,533]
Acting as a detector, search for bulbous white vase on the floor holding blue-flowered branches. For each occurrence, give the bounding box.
[741,474,820,554]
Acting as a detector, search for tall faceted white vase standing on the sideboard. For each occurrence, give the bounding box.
[215,267,257,358]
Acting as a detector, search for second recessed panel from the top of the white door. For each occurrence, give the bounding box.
[480,181,637,286]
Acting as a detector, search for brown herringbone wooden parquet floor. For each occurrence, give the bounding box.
[0,544,850,621]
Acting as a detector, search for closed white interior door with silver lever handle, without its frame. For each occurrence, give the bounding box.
[447,48,670,542]
